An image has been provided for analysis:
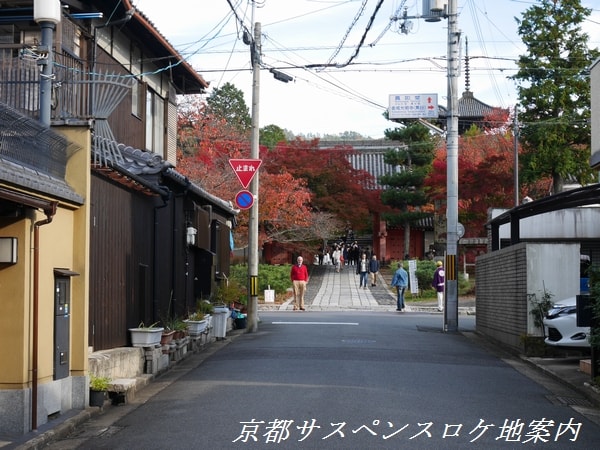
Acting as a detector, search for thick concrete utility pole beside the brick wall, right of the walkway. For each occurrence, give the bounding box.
[444,0,460,331]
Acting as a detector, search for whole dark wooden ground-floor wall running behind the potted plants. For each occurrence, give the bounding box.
[89,172,230,350]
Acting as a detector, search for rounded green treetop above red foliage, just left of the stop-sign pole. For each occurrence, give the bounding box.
[206,83,252,135]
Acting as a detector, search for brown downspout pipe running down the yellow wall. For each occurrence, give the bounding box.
[31,202,58,430]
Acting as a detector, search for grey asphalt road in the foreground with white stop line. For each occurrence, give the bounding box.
[48,311,600,450]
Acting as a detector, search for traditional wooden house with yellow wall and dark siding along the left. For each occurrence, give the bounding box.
[0,0,237,434]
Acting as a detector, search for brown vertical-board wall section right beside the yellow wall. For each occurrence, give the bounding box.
[89,175,157,350]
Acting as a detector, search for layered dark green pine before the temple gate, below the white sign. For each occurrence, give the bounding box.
[379,122,436,253]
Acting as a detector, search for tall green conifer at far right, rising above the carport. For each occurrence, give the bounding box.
[512,0,598,193]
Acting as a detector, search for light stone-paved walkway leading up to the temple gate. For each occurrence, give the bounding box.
[265,265,475,315]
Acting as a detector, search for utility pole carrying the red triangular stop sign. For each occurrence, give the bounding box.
[246,21,261,333]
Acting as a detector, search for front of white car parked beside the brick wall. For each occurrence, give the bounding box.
[543,297,590,348]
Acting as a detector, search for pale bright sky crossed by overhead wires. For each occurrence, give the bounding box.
[132,0,600,139]
